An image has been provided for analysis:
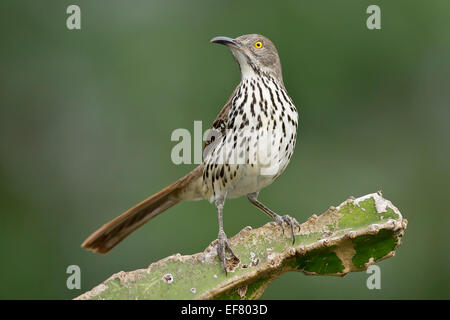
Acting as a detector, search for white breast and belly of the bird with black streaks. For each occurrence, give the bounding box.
[204,75,298,200]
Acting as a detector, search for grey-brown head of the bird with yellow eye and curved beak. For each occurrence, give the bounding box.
[211,34,283,83]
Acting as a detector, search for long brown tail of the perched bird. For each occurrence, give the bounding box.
[81,167,201,253]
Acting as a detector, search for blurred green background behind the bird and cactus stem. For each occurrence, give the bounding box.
[0,0,450,299]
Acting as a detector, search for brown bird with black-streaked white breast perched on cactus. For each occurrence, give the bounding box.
[81,34,300,273]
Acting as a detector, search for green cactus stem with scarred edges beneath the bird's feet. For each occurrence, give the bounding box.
[77,192,407,300]
